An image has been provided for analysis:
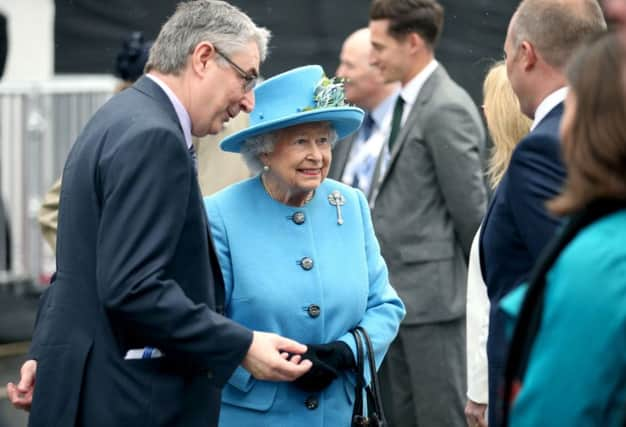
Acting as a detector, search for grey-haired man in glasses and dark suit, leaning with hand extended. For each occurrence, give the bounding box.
[8,0,310,427]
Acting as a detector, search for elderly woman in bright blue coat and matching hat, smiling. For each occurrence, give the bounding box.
[205,66,405,427]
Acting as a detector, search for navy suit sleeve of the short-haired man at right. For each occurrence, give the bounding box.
[505,135,564,259]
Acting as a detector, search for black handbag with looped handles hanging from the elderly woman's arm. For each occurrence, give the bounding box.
[350,326,388,427]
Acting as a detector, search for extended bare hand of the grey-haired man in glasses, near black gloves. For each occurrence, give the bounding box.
[242,331,313,381]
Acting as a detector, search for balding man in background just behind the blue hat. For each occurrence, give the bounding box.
[328,28,399,196]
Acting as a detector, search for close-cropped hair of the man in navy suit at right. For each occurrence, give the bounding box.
[511,0,606,69]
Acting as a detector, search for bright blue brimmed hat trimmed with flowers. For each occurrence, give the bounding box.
[220,65,364,153]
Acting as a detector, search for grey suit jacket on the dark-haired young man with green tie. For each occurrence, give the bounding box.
[370,65,486,324]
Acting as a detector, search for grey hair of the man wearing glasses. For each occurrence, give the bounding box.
[145,0,270,75]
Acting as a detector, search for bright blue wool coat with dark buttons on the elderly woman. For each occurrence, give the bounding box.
[205,177,405,427]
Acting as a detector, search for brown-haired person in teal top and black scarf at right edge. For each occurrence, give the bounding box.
[501,34,626,427]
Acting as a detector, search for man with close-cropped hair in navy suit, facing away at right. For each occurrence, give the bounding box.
[480,0,606,427]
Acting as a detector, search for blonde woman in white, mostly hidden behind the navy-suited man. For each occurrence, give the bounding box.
[465,61,531,427]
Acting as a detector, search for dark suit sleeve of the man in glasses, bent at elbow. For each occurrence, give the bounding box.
[95,128,252,385]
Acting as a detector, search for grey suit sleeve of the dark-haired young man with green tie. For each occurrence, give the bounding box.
[424,99,487,259]
